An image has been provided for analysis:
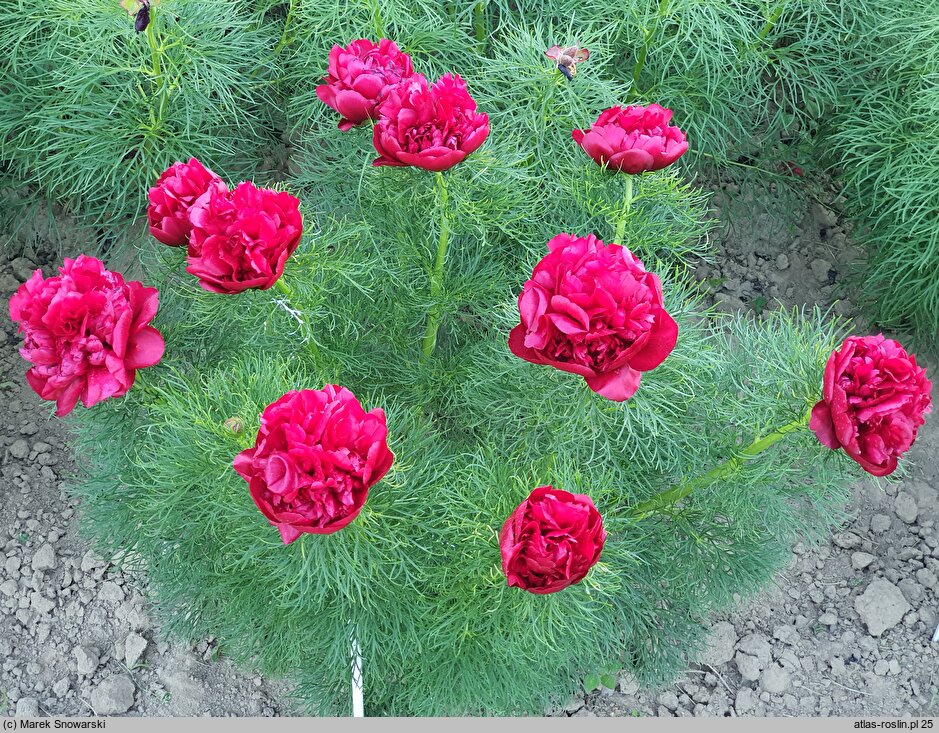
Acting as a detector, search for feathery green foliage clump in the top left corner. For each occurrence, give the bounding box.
[0,0,277,226]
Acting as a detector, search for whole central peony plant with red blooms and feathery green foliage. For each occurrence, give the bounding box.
[11,27,930,715]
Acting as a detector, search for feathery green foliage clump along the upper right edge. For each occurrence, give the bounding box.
[826,1,939,349]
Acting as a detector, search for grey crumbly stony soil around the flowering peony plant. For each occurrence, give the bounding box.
[0,183,939,716]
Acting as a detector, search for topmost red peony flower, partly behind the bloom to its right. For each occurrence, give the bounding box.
[316,38,414,132]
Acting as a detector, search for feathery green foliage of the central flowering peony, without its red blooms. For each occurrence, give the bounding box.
[70,146,846,715]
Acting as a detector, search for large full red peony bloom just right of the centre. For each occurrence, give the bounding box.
[509,234,678,402]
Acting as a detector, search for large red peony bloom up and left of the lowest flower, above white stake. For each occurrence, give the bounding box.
[234,384,394,545]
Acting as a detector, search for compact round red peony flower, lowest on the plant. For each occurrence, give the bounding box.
[499,486,606,594]
